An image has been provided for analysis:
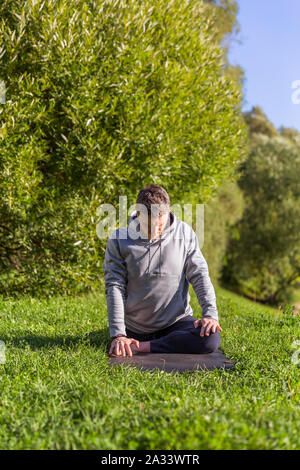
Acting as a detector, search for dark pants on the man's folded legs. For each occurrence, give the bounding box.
[126,315,221,354]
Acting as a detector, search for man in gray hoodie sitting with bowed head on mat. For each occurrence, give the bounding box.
[103,184,222,356]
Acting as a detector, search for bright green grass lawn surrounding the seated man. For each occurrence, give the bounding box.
[0,287,300,450]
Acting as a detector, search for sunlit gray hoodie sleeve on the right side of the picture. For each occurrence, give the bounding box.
[184,228,218,320]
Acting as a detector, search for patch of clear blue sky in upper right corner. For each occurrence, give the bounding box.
[229,0,300,131]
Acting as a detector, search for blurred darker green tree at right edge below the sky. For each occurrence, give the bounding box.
[223,128,300,304]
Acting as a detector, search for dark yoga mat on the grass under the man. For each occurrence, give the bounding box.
[109,349,234,372]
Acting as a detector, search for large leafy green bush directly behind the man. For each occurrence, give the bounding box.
[0,0,245,294]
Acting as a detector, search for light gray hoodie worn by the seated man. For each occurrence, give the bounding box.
[103,211,218,337]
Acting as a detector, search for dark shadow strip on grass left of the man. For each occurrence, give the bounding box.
[0,328,110,350]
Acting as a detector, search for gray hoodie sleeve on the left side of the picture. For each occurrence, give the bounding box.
[102,234,127,337]
